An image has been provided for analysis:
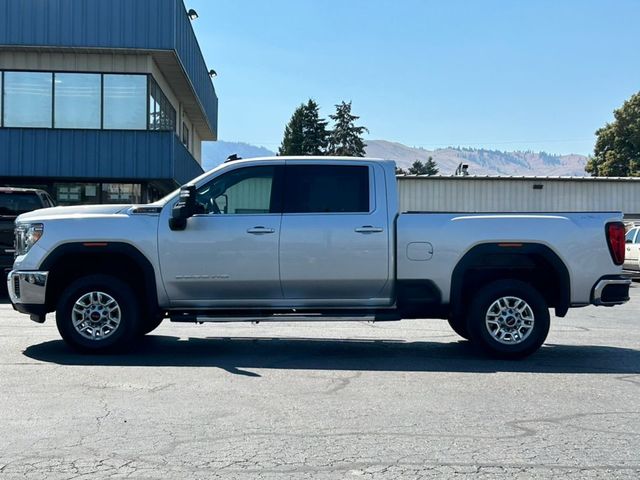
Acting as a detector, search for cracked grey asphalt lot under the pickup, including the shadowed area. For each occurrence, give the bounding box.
[0,287,640,480]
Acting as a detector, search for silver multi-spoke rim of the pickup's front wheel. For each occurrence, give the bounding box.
[71,292,122,341]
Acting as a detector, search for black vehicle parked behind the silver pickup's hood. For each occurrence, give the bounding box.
[0,187,55,275]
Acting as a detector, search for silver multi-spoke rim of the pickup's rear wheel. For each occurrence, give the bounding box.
[485,297,535,345]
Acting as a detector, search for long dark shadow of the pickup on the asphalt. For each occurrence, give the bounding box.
[24,335,640,376]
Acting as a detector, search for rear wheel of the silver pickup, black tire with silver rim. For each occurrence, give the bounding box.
[467,279,550,358]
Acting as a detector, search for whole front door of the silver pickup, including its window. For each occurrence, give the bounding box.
[158,166,284,308]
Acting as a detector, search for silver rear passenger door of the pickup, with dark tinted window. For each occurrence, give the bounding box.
[280,162,391,306]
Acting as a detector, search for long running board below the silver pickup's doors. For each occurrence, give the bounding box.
[169,311,401,323]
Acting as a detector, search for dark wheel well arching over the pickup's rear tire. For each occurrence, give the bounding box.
[451,244,570,317]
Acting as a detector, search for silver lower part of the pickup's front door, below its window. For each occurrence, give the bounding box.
[159,215,282,303]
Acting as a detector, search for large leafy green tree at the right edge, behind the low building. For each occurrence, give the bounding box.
[585,92,640,177]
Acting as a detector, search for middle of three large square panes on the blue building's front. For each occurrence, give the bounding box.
[53,73,102,129]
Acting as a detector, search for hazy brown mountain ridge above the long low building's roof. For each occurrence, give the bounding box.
[367,140,587,176]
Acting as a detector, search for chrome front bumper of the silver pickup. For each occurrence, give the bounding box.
[7,270,49,323]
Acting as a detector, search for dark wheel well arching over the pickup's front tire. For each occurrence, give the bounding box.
[41,244,158,314]
